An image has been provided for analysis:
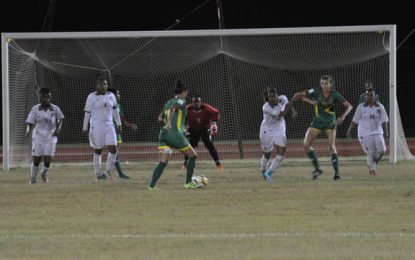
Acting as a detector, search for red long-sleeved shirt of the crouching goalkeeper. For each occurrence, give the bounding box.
[186,103,219,130]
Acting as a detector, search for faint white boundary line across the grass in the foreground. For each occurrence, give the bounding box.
[0,232,415,241]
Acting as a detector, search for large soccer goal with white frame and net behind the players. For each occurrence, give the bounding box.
[2,25,413,170]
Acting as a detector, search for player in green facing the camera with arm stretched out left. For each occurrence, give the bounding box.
[294,75,353,180]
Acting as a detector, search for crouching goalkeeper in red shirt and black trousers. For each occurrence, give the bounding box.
[182,96,222,170]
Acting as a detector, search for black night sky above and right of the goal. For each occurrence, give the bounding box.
[1,0,415,136]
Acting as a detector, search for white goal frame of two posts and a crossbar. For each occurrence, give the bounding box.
[1,25,398,170]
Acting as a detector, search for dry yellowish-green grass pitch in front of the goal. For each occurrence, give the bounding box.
[0,160,415,259]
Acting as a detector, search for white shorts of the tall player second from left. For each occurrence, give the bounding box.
[89,125,117,149]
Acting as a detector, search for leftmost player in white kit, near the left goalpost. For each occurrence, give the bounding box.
[26,88,64,184]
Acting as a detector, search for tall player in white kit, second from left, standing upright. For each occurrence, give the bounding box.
[82,78,121,180]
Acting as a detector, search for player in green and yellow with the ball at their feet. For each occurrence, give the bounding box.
[148,80,200,189]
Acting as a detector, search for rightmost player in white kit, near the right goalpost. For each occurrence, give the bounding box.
[347,91,389,176]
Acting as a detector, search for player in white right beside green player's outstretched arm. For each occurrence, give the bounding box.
[259,88,292,181]
